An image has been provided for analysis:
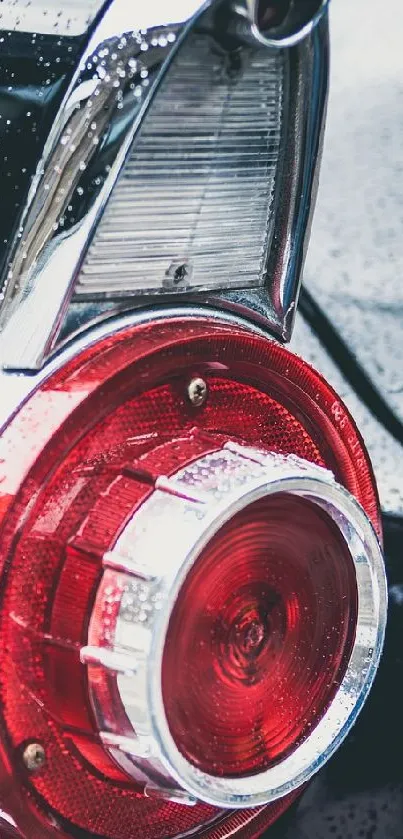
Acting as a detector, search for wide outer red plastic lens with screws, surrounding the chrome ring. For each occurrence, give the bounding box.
[0,318,380,839]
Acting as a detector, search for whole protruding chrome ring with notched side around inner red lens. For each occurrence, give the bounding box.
[83,444,387,809]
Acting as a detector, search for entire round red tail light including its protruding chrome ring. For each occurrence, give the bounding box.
[0,310,386,839]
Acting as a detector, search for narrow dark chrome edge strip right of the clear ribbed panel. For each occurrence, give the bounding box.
[210,14,329,342]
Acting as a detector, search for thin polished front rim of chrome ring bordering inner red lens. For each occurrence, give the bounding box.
[148,464,387,808]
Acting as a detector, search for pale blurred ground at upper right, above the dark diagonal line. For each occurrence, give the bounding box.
[305,0,403,419]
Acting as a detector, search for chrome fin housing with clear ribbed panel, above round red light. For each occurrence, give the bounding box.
[0,0,328,370]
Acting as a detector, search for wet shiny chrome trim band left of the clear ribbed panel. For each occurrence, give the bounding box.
[0,0,213,370]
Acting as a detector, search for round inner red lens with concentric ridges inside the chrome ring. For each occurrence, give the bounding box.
[163,494,357,777]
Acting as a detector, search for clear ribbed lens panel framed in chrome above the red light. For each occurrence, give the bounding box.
[76,34,285,297]
